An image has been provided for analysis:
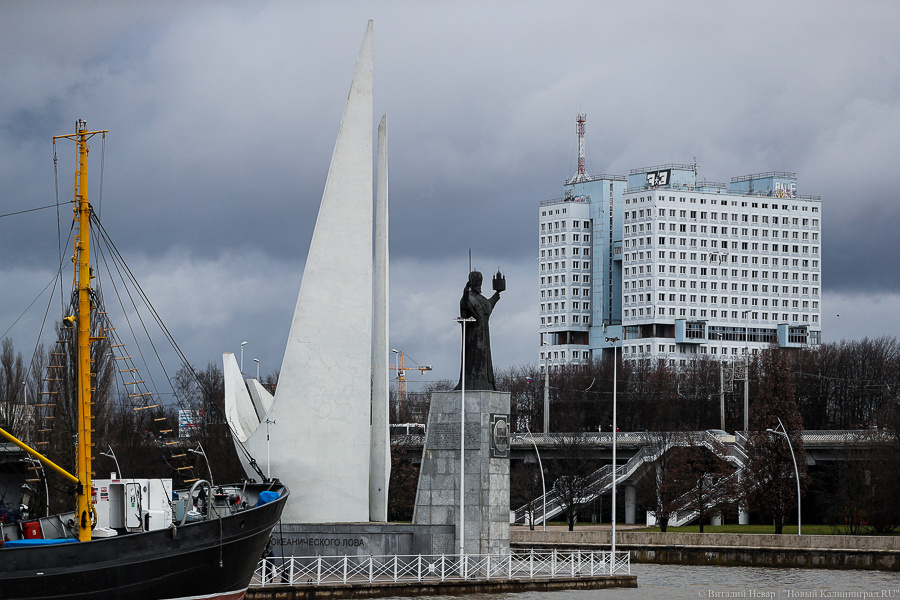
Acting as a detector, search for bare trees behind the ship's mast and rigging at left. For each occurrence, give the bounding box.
[0,326,248,515]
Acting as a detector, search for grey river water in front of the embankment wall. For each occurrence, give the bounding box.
[382,563,900,600]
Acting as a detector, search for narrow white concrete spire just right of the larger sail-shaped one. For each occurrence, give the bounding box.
[369,115,391,522]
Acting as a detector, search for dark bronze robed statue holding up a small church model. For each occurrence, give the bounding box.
[455,271,506,390]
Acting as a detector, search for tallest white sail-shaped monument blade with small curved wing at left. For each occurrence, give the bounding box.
[226,21,389,523]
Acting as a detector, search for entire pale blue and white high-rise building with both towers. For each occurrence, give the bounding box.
[539,129,822,368]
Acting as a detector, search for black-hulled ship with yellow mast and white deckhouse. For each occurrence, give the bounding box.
[0,120,289,600]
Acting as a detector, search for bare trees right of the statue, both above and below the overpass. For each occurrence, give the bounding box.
[498,338,900,533]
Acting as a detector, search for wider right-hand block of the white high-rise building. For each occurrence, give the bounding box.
[622,164,822,366]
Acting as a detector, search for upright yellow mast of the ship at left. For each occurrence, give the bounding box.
[53,120,107,542]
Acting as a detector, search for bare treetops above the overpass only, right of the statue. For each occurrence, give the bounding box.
[497,337,900,432]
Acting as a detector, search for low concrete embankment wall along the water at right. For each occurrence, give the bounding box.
[510,528,900,571]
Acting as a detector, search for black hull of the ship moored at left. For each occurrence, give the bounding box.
[0,486,288,600]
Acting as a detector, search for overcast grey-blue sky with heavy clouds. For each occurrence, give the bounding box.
[0,0,900,392]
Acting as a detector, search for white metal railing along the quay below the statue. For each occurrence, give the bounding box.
[250,548,631,587]
